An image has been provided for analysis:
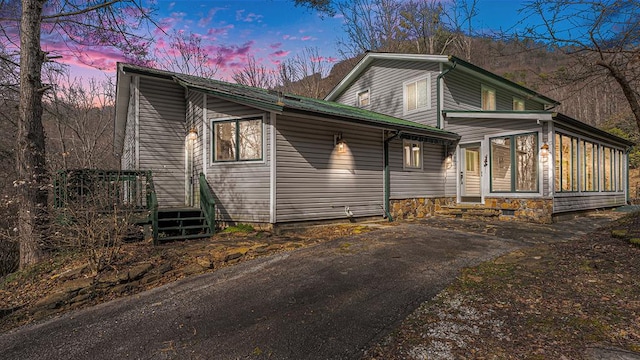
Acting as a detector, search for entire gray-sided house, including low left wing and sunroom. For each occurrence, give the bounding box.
[114,53,632,233]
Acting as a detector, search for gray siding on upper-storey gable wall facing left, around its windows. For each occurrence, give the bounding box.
[335,60,440,126]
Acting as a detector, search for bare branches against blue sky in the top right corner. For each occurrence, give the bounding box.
[519,0,640,129]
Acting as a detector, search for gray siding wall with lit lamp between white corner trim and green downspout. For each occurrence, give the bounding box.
[276,116,384,222]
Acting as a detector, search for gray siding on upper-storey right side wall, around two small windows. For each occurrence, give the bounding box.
[443,69,544,111]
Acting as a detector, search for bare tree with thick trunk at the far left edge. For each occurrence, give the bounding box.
[0,0,154,268]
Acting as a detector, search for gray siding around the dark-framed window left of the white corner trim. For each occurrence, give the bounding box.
[205,96,271,223]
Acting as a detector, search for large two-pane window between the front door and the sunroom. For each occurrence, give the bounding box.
[491,133,539,192]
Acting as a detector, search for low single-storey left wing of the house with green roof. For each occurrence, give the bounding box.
[114,64,460,232]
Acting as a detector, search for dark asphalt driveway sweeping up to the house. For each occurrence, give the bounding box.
[0,215,606,360]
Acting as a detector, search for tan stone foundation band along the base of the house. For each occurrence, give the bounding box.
[391,197,553,224]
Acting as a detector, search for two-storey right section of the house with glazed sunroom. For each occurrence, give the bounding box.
[325,53,633,222]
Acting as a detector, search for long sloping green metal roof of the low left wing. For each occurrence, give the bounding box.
[122,64,460,141]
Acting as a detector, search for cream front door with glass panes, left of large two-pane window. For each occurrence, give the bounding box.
[459,143,482,202]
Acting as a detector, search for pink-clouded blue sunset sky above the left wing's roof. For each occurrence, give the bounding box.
[43,0,344,80]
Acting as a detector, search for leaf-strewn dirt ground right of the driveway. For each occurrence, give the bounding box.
[365,213,640,359]
